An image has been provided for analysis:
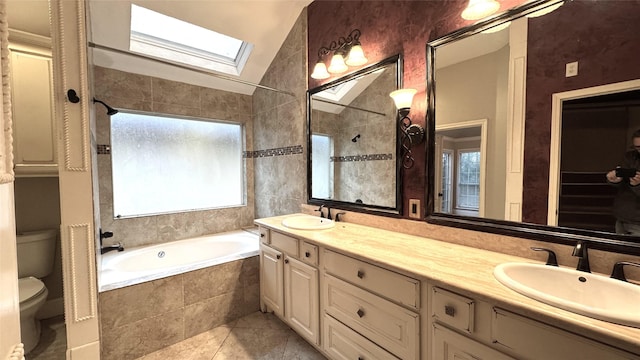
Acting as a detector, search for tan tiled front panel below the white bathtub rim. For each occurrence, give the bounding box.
[99,256,260,360]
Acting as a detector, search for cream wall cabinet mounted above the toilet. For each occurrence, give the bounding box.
[9,37,58,176]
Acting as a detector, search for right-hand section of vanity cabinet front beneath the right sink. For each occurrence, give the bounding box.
[430,286,640,360]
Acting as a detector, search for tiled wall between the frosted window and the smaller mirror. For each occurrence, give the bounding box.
[253,9,307,218]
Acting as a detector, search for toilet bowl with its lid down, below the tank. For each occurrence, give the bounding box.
[18,276,49,353]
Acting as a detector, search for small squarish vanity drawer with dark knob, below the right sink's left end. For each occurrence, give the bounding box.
[431,287,475,333]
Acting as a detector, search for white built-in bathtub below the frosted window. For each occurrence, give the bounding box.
[98,230,260,291]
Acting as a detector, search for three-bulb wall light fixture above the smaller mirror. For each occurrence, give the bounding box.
[311,29,367,80]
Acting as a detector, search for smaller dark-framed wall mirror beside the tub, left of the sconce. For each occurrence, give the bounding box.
[307,55,402,214]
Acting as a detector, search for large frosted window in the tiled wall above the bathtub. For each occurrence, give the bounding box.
[111,111,244,217]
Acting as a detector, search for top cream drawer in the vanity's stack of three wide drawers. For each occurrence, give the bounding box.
[323,250,420,309]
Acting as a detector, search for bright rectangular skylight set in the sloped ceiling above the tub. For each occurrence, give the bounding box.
[129,4,253,75]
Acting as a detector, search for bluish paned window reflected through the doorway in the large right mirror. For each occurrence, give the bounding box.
[456,149,480,210]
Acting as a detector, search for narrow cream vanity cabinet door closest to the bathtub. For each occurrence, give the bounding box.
[260,245,284,317]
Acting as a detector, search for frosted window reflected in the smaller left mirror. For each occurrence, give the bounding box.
[311,134,333,199]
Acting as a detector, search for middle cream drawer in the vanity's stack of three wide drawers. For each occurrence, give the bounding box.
[322,275,420,360]
